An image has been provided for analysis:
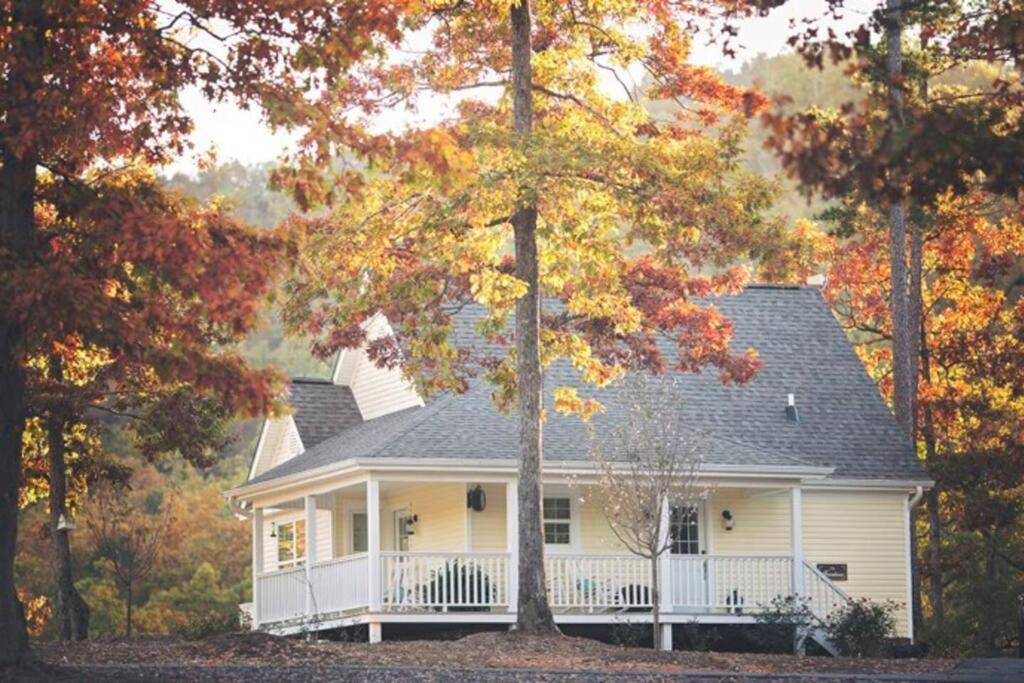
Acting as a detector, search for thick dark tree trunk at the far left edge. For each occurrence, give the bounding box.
[0,0,43,667]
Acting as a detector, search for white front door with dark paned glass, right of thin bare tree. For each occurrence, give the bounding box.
[666,504,709,611]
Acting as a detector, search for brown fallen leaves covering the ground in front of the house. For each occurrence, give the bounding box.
[35,633,956,674]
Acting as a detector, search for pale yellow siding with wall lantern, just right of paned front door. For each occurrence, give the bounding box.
[701,488,793,555]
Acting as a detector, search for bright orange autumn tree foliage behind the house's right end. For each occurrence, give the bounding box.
[826,191,1024,652]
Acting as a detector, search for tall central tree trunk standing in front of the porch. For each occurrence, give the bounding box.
[511,0,557,633]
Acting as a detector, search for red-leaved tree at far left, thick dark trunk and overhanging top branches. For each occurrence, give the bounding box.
[0,0,400,666]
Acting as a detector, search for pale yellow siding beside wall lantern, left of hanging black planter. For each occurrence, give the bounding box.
[381,482,467,552]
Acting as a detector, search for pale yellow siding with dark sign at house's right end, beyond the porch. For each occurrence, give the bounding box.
[803,490,907,634]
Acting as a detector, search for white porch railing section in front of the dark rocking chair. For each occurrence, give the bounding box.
[381,552,509,611]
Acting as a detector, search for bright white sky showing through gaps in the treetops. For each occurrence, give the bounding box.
[167,0,876,173]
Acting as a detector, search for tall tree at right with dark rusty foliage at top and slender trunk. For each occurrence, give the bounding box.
[765,0,1024,624]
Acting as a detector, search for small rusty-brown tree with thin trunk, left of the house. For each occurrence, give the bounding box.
[91,490,170,638]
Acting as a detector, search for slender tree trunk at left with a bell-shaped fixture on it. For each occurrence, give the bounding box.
[47,368,89,640]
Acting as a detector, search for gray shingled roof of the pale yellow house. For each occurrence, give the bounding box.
[251,287,926,483]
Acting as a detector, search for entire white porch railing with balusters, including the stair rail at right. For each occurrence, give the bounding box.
[256,552,847,624]
